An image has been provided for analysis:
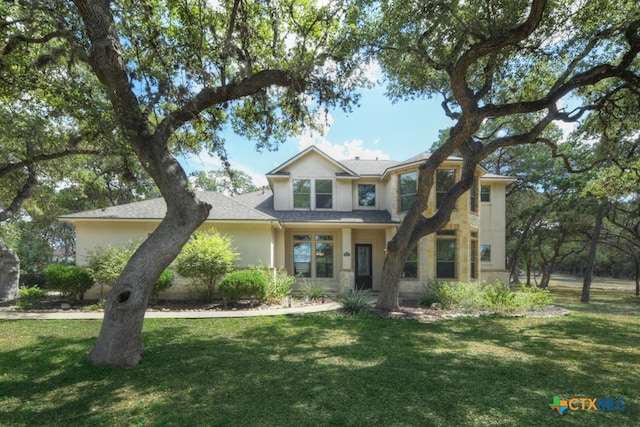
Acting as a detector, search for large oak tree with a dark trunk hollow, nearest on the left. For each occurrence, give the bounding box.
[1,0,361,367]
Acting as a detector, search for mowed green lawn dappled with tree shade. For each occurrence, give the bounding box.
[0,282,640,426]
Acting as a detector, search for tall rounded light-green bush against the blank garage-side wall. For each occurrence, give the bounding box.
[175,230,239,302]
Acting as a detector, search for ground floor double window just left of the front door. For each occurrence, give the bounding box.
[293,234,334,278]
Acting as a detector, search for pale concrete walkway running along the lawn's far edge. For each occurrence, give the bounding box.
[0,302,340,320]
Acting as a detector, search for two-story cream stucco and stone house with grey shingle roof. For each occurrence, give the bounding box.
[61,146,514,297]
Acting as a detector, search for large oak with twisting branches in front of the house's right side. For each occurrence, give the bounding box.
[350,0,640,310]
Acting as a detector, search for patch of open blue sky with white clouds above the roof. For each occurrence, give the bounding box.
[181,86,453,185]
